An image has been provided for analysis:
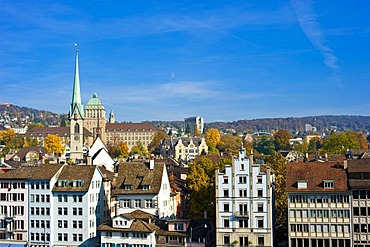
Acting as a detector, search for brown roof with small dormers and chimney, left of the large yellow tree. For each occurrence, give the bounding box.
[113,162,164,195]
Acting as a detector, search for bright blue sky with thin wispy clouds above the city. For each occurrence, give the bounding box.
[0,0,370,122]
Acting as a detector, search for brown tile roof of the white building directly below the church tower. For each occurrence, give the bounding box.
[53,165,97,192]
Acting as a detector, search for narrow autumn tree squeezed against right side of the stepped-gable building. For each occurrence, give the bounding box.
[265,152,288,245]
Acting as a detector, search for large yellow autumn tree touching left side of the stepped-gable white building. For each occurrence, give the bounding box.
[186,157,231,219]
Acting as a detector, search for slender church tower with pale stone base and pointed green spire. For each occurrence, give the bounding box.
[69,44,84,162]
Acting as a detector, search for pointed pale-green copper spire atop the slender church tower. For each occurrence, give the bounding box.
[69,44,84,118]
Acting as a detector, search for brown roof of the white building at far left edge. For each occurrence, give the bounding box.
[0,164,63,180]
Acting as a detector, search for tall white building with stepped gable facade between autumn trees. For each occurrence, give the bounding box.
[216,150,274,246]
